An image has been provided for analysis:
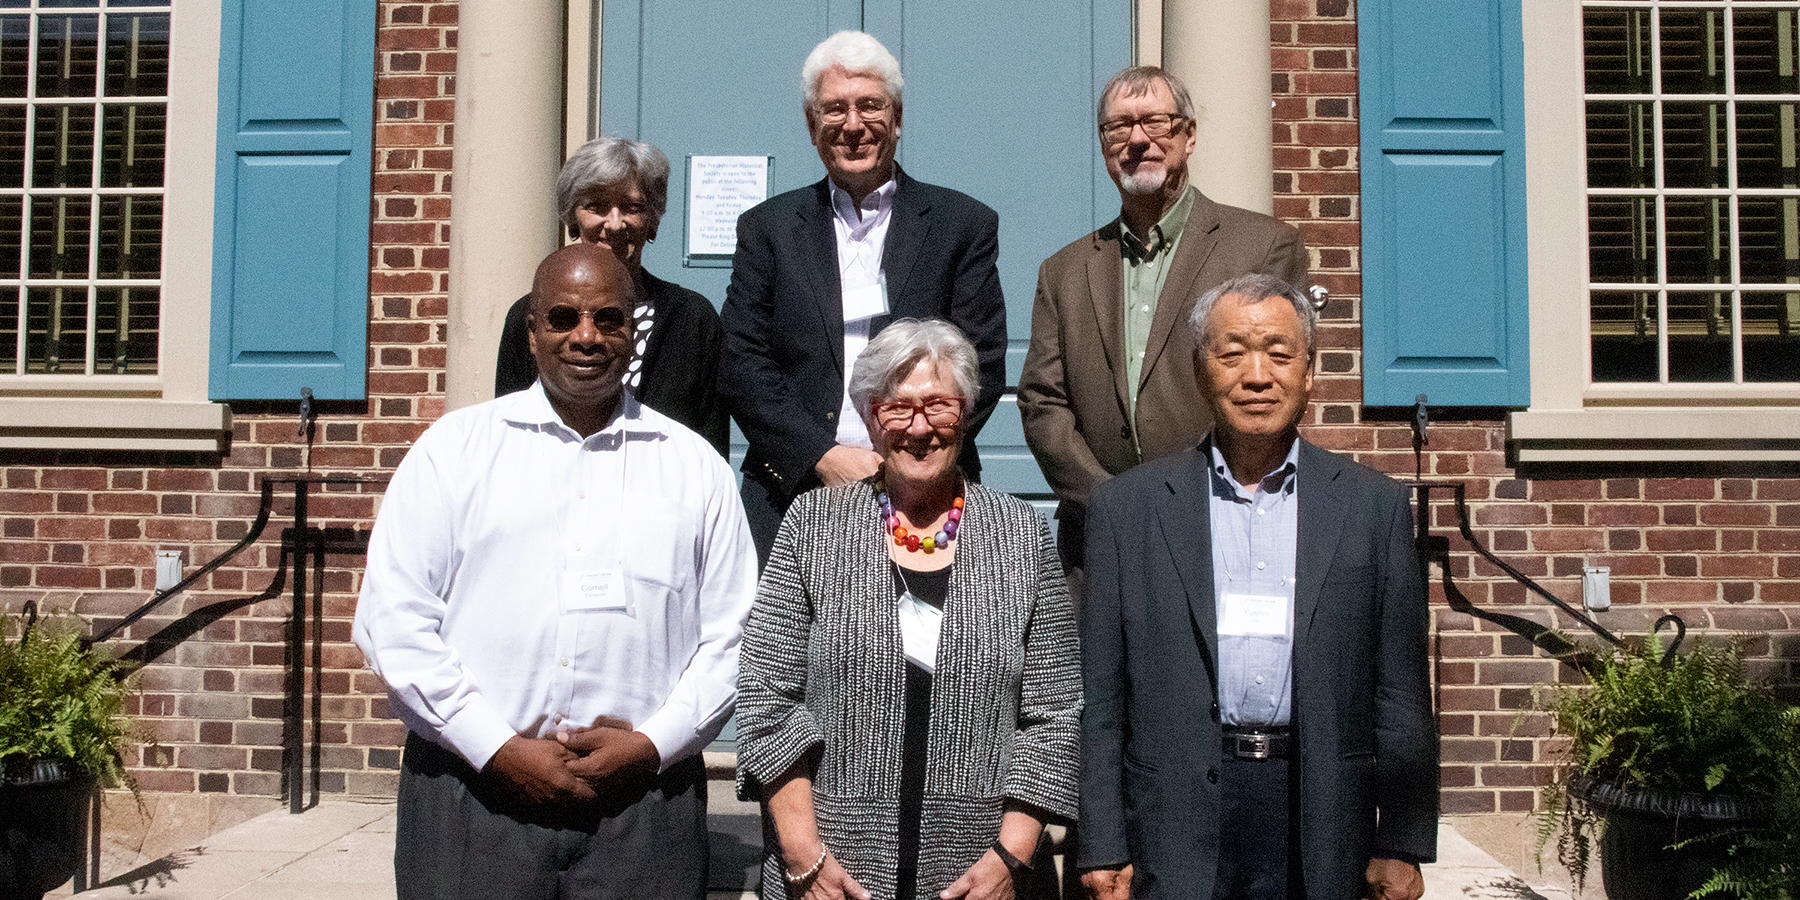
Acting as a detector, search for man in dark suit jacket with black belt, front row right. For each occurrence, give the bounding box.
[1078,275,1438,900]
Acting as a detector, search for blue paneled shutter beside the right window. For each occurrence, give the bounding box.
[1357,0,1526,407]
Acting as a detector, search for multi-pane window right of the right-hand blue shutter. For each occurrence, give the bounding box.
[1582,0,1800,385]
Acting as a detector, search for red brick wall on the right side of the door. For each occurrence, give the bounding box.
[1271,0,1800,814]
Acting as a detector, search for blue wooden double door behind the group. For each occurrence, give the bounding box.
[599,0,1130,497]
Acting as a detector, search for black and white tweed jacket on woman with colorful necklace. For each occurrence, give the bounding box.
[738,482,1082,900]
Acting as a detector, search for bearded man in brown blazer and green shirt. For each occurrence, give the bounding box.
[1019,67,1307,569]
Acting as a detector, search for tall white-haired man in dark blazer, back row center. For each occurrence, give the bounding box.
[718,31,1006,560]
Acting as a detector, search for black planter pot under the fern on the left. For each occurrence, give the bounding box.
[0,761,94,900]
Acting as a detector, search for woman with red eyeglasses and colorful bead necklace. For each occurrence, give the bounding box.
[738,319,1082,900]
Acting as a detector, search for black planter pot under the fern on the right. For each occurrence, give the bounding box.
[1570,779,1773,900]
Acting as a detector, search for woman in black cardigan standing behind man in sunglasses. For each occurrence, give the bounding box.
[493,137,731,455]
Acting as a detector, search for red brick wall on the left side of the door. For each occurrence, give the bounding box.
[0,0,457,796]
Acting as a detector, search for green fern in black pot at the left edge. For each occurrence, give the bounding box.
[0,605,131,900]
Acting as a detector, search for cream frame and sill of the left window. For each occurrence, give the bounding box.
[0,0,230,454]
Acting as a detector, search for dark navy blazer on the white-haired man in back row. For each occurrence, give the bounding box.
[718,169,1006,508]
